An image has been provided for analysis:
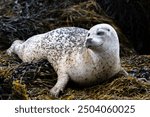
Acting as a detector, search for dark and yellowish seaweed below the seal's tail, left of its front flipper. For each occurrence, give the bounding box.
[0,52,57,99]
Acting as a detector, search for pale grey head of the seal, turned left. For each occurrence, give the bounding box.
[85,24,119,53]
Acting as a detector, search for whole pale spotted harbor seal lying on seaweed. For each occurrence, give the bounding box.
[7,24,127,97]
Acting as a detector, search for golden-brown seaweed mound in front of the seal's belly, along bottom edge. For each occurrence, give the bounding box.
[60,77,150,100]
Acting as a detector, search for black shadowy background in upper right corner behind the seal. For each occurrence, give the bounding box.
[97,0,150,54]
